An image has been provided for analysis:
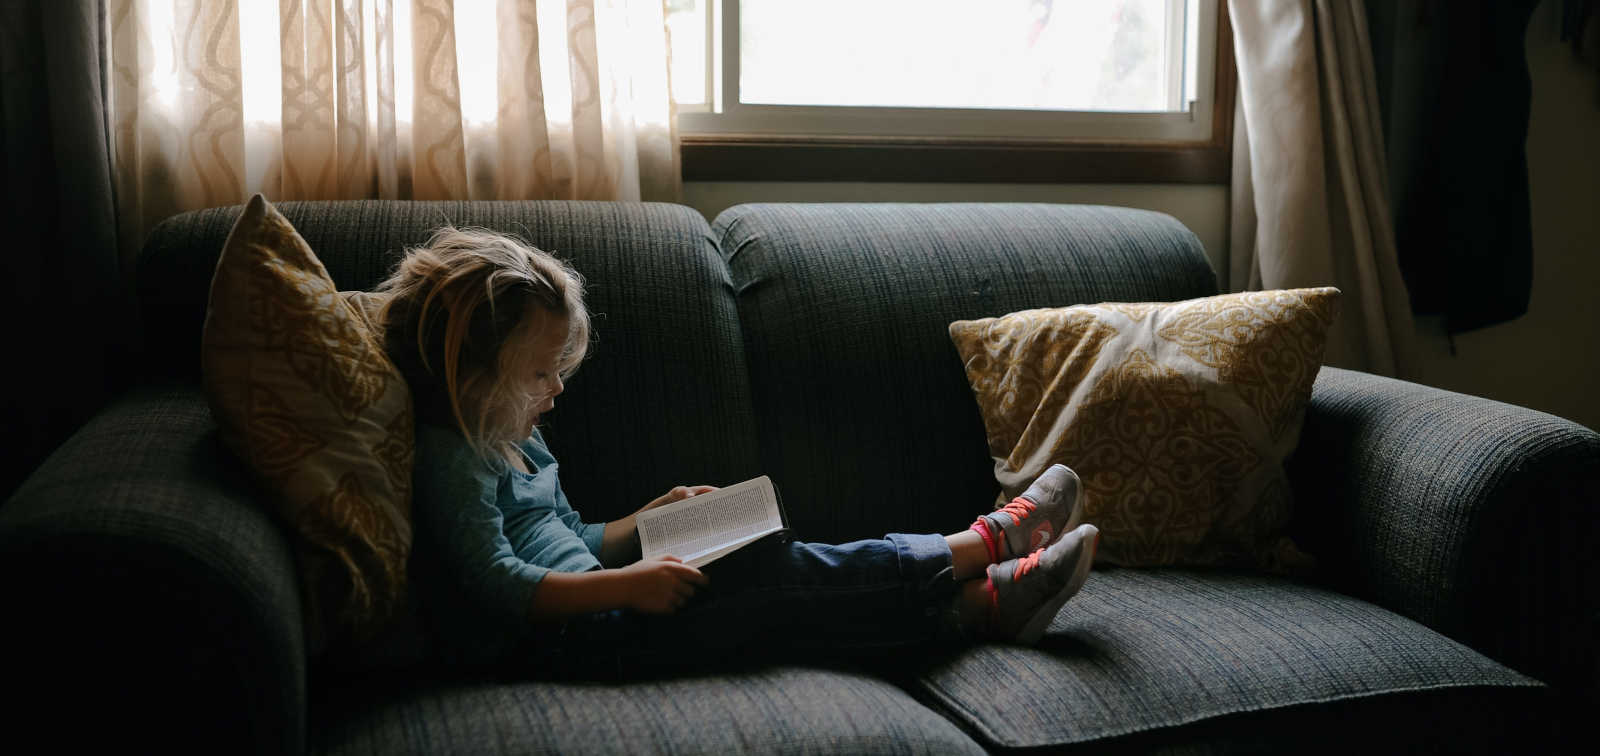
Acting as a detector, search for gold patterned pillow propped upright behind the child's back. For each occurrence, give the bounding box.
[202,194,414,652]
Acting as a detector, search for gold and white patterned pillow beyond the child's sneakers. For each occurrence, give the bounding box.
[950,287,1339,572]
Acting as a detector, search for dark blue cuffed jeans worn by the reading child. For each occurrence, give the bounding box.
[520,533,960,676]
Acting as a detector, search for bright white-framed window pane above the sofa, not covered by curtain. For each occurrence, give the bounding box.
[667,0,1216,139]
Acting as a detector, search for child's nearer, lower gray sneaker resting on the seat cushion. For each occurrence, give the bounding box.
[989,524,1099,645]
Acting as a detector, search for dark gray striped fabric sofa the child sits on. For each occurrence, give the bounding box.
[0,202,1600,753]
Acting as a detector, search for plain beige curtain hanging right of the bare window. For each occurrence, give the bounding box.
[1227,0,1416,376]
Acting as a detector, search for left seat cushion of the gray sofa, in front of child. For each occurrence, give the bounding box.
[314,666,984,754]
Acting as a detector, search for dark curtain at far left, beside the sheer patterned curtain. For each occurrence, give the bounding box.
[0,0,134,500]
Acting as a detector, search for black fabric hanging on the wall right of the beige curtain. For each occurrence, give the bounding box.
[1366,0,1538,333]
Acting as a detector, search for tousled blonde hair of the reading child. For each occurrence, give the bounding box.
[378,226,589,461]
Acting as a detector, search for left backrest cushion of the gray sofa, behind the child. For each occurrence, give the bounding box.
[136,200,760,522]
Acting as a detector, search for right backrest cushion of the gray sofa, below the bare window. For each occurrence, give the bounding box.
[712,203,1216,540]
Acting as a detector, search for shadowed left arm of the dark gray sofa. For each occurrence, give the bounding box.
[0,386,307,753]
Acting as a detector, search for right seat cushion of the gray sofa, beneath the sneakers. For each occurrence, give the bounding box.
[918,569,1549,750]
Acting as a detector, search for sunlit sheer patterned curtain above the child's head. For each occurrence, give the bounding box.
[107,0,682,254]
